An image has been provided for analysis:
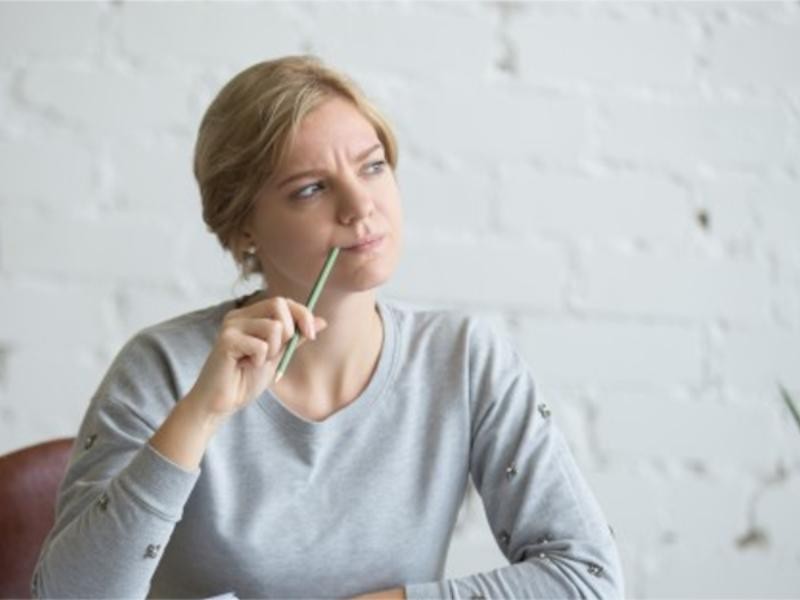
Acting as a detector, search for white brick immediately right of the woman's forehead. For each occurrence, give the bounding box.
[382,81,588,168]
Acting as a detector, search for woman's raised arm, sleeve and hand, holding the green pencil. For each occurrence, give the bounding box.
[32,297,326,597]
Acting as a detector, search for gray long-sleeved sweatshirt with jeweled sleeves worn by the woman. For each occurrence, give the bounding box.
[32,298,623,598]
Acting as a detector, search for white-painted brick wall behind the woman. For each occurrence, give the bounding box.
[0,2,800,598]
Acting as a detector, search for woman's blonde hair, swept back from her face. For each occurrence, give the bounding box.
[194,55,397,279]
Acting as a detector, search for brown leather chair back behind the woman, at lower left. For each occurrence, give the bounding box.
[0,438,74,598]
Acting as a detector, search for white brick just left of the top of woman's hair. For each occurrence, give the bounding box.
[22,63,198,137]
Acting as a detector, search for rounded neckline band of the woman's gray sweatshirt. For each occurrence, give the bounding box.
[234,298,398,437]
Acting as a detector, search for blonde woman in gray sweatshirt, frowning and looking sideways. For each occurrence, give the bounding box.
[33,57,623,598]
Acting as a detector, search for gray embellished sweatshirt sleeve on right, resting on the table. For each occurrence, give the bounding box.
[405,316,624,599]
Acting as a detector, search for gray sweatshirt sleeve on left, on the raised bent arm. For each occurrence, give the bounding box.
[31,330,200,598]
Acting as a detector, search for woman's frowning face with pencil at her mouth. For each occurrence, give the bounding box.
[242,97,402,301]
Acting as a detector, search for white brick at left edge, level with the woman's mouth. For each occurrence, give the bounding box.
[0,213,176,283]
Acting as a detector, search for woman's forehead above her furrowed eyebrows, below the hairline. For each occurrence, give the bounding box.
[286,97,378,164]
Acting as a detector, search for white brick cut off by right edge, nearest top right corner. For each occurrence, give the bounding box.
[705,17,800,89]
